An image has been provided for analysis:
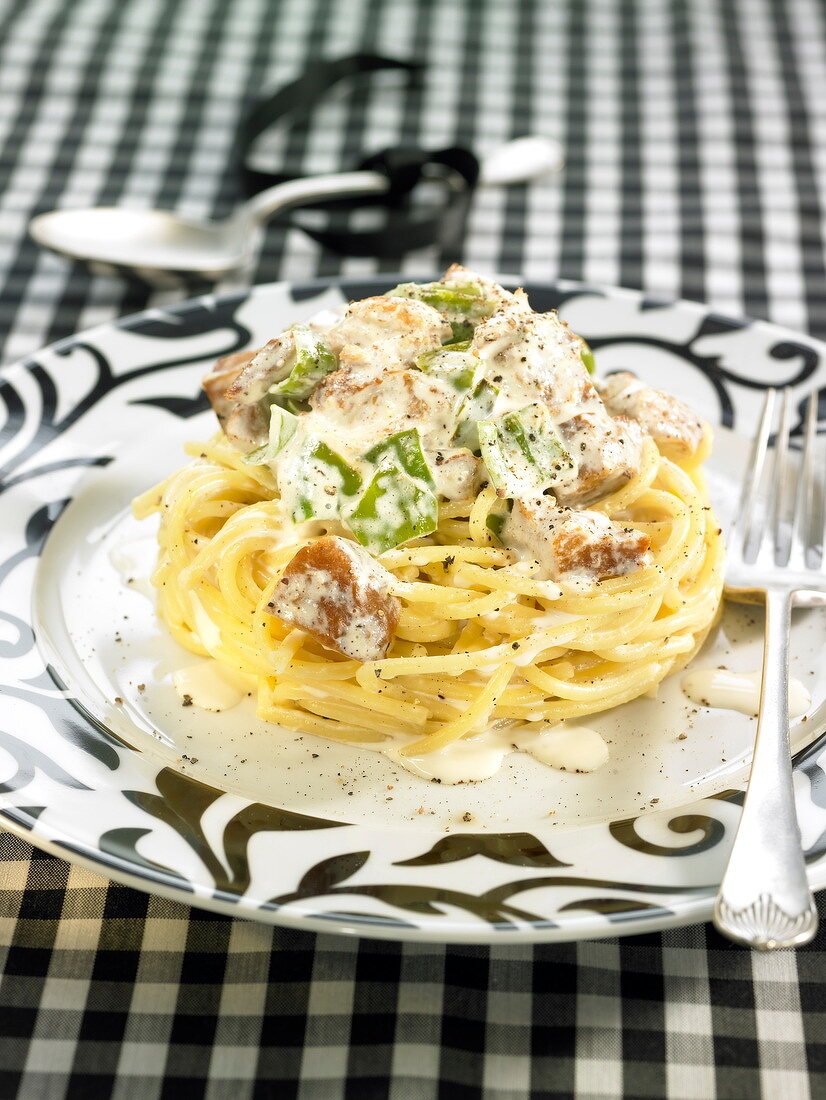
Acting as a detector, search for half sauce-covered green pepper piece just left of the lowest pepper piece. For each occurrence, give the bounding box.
[279,436,362,524]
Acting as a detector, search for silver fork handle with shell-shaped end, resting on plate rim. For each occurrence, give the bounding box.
[714,591,817,950]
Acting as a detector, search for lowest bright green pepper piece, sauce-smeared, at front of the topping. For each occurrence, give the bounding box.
[345,465,439,554]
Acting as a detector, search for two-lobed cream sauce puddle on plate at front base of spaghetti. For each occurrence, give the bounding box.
[363,723,608,785]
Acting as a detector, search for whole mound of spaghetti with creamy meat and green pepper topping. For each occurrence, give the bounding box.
[134,265,723,756]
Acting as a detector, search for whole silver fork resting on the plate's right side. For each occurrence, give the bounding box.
[714,389,826,950]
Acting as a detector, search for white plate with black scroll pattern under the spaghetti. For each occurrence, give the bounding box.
[0,276,826,944]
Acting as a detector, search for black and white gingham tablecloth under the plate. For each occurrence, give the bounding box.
[0,0,826,1100]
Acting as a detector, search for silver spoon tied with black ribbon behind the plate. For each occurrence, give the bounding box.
[29,136,563,281]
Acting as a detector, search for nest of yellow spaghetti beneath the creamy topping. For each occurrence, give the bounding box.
[134,432,724,755]
